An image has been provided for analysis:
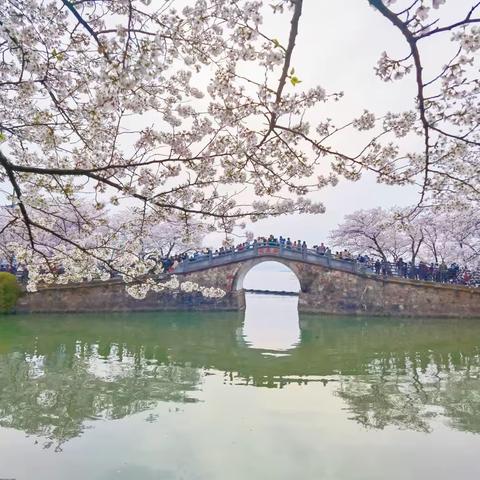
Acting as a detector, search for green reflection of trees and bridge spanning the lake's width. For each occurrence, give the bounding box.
[0,313,480,450]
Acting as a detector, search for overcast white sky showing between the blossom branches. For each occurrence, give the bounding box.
[224,0,472,245]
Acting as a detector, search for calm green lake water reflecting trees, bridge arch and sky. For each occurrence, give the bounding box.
[0,268,480,480]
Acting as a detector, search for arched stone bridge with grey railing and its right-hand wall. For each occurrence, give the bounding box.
[175,246,480,318]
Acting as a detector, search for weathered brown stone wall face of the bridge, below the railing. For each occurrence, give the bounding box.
[17,255,480,318]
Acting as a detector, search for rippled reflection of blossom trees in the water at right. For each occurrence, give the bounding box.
[337,353,480,433]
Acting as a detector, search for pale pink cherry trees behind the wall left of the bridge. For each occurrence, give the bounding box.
[0,204,205,289]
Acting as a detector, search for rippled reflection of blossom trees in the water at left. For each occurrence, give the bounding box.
[0,342,200,451]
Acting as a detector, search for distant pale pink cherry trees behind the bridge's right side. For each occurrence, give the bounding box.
[330,206,480,269]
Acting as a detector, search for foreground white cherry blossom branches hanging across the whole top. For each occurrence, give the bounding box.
[0,0,480,292]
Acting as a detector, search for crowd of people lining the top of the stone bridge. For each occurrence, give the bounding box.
[0,235,480,287]
